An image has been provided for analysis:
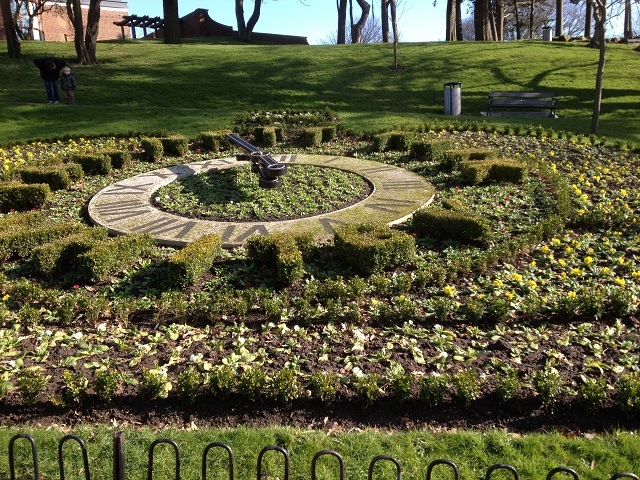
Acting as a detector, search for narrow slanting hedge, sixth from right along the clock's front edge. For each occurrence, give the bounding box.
[31,227,109,278]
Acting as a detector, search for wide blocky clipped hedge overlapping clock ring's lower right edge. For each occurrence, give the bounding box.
[334,223,415,275]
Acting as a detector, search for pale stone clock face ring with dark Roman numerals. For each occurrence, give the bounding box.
[89,155,435,248]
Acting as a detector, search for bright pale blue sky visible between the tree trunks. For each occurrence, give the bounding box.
[122,0,446,45]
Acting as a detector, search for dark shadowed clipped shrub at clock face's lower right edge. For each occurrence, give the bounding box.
[412,207,491,243]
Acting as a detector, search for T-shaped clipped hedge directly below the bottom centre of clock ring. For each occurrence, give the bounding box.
[247,233,313,285]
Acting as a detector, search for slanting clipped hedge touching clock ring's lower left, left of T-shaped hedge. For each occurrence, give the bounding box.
[169,235,222,288]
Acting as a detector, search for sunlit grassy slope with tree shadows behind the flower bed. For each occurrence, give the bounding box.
[0,41,640,144]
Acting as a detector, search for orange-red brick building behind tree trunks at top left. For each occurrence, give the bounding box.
[0,0,130,42]
